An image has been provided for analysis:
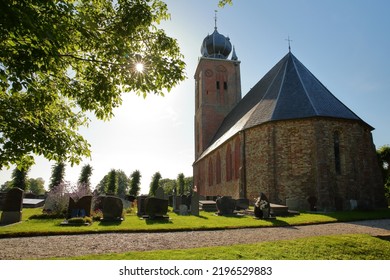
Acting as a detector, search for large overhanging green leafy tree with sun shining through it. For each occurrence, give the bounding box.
[0,0,185,168]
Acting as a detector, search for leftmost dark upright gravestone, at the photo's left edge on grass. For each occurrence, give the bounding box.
[0,188,24,224]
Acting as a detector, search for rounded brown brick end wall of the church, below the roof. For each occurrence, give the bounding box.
[245,118,384,210]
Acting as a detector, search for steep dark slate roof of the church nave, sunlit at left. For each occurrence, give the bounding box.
[198,52,373,163]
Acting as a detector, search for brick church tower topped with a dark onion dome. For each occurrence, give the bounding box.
[194,22,241,160]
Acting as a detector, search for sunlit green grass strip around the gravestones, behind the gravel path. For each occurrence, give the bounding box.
[0,208,390,238]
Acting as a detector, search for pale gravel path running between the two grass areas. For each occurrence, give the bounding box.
[0,219,390,260]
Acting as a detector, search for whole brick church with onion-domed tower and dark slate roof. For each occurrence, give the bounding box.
[193,27,386,211]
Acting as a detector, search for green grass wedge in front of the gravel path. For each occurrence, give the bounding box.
[60,234,390,260]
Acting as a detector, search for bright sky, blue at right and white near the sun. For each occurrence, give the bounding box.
[0,0,390,193]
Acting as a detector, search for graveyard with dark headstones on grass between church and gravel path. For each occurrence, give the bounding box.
[0,186,390,237]
